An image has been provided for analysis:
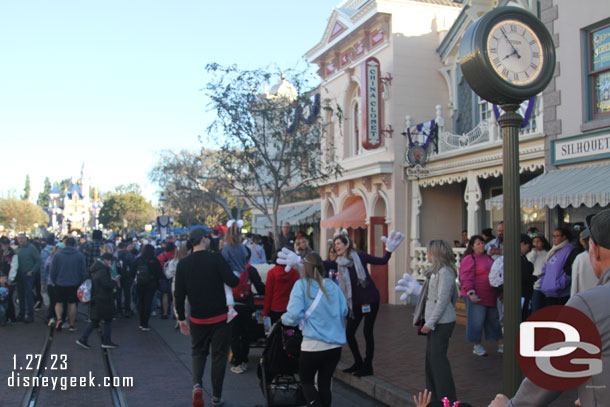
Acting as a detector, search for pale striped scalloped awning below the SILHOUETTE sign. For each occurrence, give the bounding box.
[485,164,610,210]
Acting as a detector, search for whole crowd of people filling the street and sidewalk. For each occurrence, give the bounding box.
[0,210,610,407]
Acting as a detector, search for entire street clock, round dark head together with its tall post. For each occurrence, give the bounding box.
[459,7,555,396]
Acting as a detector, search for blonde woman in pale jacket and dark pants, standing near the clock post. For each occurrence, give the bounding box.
[421,240,459,401]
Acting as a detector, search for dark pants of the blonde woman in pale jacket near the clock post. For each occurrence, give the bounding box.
[426,322,456,401]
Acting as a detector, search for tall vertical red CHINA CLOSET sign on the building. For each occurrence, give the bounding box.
[362,57,382,150]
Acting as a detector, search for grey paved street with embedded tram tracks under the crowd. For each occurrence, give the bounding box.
[0,315,383,407]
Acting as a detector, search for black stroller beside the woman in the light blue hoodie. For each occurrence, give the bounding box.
[257,321,307,407]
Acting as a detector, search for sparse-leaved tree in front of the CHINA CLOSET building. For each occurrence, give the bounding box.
[205,64,341,252]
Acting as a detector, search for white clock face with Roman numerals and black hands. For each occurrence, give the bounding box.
[487,20,544,86]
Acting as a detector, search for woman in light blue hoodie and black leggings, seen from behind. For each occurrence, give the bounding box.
[282,252,347,407]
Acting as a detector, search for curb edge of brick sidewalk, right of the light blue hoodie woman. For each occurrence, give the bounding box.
[334,362,415,407]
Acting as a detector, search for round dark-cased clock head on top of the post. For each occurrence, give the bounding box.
[459,7,555,105]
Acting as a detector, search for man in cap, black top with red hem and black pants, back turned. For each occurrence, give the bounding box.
[174,228,239,407]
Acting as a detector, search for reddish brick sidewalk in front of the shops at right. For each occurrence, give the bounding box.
[335,304,577,407]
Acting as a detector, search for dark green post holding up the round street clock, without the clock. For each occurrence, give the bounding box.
[498,104,523,397]
